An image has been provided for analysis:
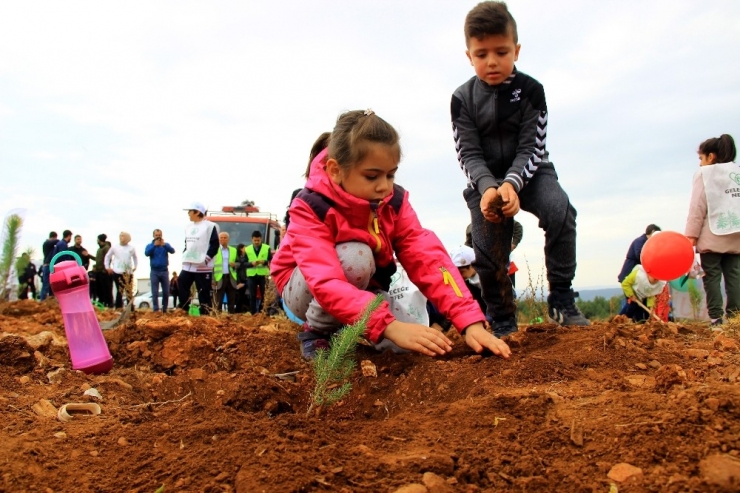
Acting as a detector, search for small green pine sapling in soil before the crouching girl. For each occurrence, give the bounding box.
[306,294,383,415]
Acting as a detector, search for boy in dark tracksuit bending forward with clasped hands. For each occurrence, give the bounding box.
[451,1,589,333]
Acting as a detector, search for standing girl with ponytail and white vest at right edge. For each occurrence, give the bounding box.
[686,134,740,326]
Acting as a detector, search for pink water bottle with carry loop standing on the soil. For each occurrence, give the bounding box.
[49,251,113,373]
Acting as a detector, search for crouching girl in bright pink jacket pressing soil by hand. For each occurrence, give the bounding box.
[271,110,511,359]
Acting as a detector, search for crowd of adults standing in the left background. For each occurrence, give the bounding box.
[25,202,273,314]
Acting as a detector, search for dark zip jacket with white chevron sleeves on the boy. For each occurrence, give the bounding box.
[451,69,553,195]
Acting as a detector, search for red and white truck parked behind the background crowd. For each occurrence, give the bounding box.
[207,205,280,251]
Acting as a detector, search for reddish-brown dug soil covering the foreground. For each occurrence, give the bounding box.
[0,301,740,493]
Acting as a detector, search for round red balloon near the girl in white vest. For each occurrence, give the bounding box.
[640,231,694,281]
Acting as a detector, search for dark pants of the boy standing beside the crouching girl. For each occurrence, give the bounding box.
[463,168,576,321]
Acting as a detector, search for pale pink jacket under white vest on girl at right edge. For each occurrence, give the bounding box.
[684,171,740,253]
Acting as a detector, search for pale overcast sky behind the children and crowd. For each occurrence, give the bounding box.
[0,0,740,288]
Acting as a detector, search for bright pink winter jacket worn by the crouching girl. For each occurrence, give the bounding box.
[270,150,485,342]
